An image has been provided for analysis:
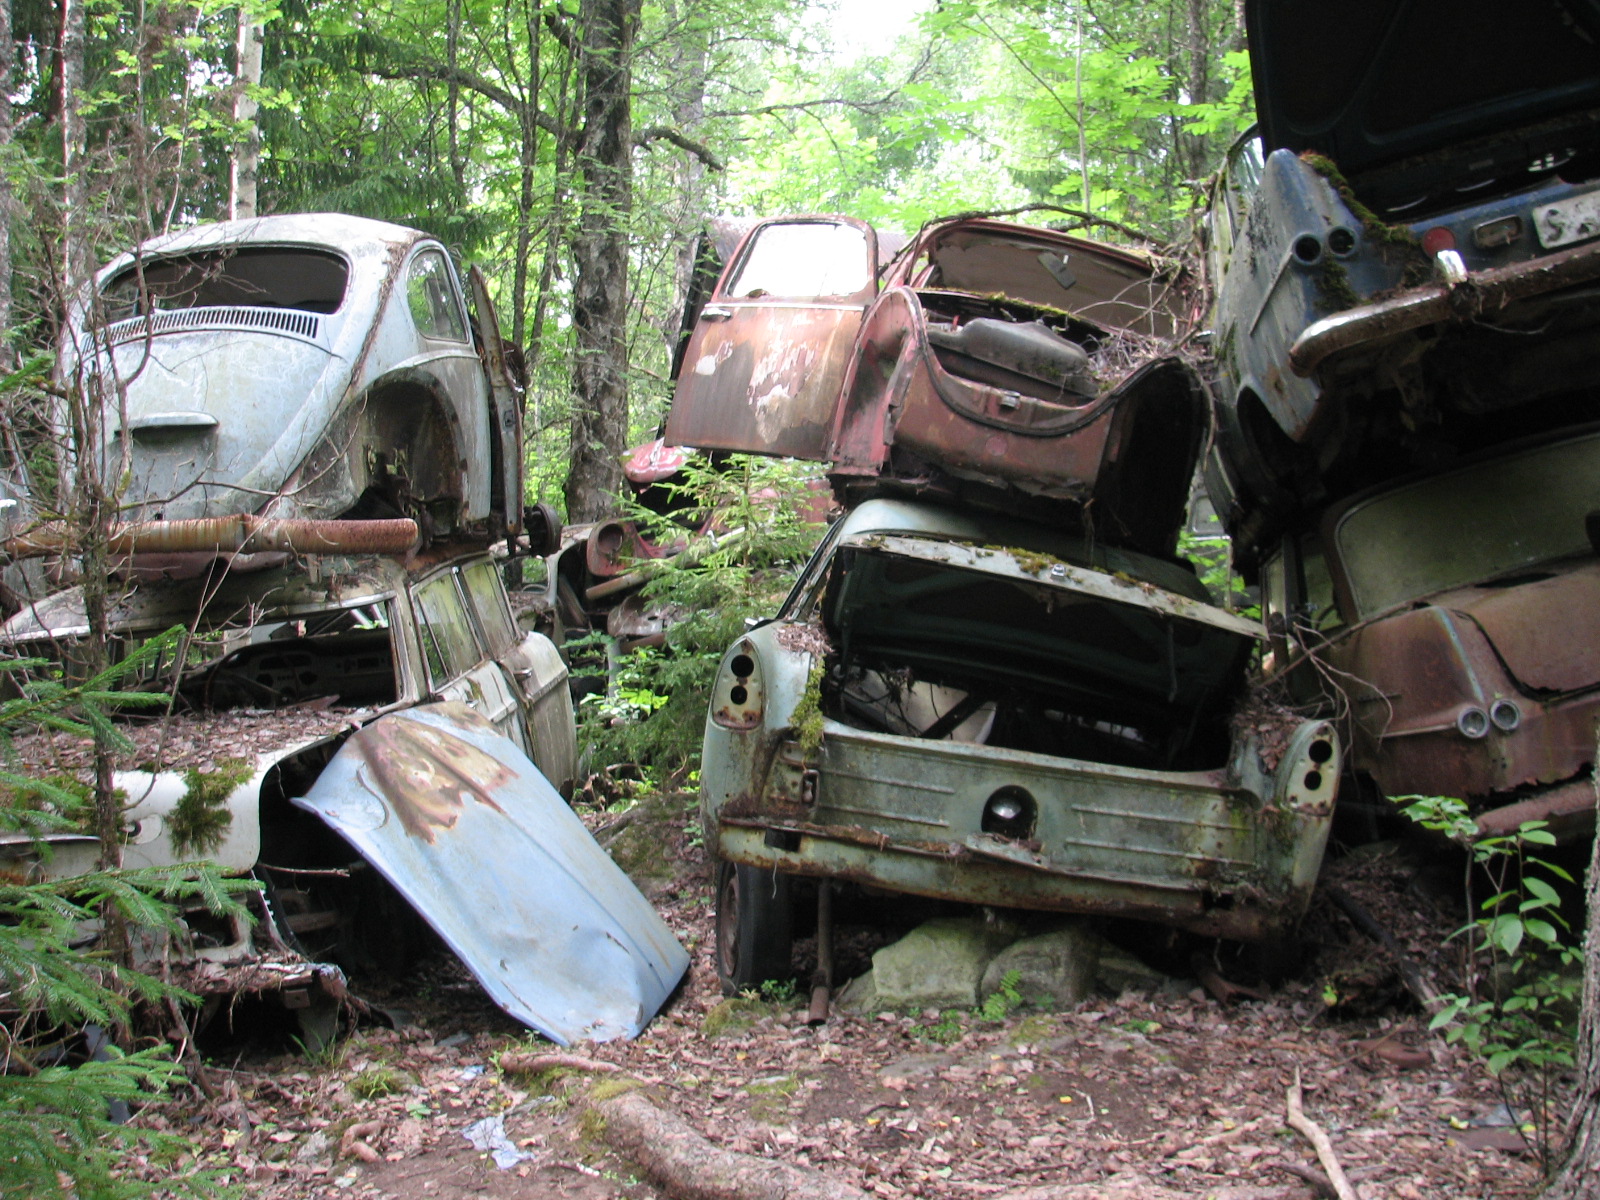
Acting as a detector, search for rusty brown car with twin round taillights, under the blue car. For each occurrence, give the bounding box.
[1262,426,1600,840]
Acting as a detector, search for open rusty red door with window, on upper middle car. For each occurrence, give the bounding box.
[666,216,878,461]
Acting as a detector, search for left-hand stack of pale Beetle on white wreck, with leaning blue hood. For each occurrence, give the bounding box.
[0,214,688,1043]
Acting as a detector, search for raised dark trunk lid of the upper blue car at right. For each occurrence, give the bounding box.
[1245,0,1600,176]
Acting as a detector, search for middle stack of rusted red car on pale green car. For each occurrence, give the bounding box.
[667,216,1341,987]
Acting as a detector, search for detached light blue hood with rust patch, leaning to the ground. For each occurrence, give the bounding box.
[294,704,688,1045]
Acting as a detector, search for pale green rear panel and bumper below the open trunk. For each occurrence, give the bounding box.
[717,722,1338,938]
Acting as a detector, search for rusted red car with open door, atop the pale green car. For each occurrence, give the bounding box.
[666,216,1208,554]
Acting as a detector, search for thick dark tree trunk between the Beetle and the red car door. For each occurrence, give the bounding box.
[566,0,640,522]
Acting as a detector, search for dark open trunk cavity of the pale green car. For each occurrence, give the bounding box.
[822,552,1251,770]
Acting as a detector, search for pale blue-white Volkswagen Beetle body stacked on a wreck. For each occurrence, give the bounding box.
[58,213,522,549]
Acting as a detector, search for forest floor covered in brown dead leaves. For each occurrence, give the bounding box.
[146,798,1563,1200]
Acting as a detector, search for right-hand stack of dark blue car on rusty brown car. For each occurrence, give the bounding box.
[1206,0,1600,837]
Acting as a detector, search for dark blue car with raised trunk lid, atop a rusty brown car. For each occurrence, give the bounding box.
[1208,0,1600,568]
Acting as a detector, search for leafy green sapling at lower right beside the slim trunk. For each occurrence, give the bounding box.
[1398,795,1582,1173]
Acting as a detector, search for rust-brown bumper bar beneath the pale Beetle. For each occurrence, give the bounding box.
[0,514,419,558]
